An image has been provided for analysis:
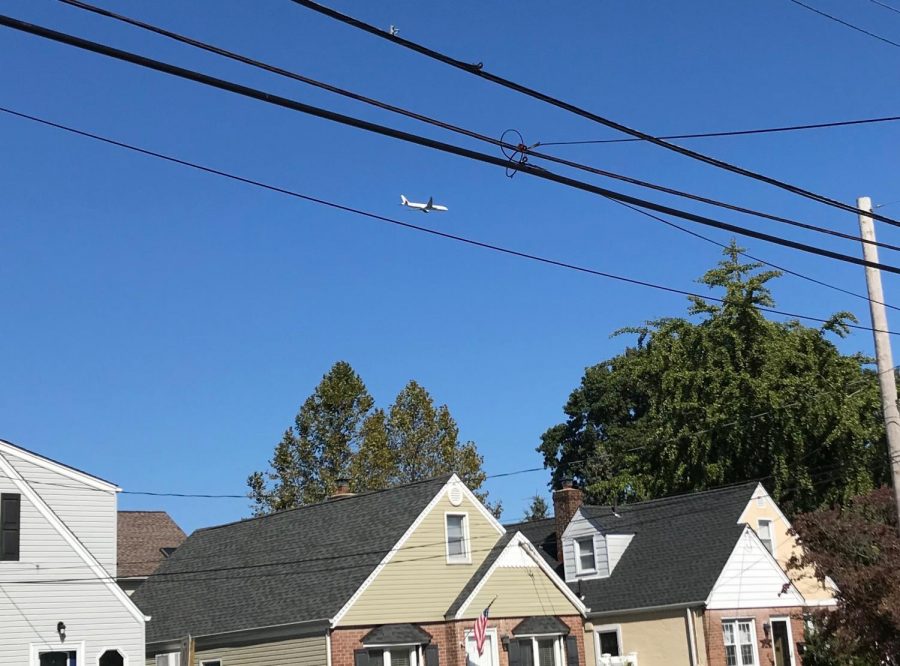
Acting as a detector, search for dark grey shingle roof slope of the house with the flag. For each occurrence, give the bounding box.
[133,475,452,643]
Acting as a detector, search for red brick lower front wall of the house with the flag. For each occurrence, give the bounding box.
[331,615,585,666]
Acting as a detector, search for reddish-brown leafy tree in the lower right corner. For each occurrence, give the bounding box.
[789,488,900,666]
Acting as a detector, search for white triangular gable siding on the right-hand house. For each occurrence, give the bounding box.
[706,527,805,609]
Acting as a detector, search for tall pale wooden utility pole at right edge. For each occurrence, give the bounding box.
[856,197,900,525]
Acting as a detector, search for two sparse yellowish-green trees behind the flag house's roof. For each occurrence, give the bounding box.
[247,361,492,515]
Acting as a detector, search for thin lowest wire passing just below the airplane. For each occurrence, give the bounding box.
[0,107,900,335]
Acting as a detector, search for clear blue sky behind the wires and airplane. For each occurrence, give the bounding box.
[0,0,900,531]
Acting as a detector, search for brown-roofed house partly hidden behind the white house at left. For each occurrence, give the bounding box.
[116,511,187,596]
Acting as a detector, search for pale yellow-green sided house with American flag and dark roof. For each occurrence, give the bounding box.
[133,475,587,666]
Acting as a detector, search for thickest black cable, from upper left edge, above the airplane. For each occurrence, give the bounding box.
[0,15,900,274]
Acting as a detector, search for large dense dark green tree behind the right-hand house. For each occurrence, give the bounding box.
[538,242,885,510]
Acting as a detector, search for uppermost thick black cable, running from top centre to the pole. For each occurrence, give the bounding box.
[292,0,900,227]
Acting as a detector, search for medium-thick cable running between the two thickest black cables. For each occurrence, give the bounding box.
[54,0,900,251]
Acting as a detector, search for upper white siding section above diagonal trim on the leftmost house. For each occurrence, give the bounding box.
[6,455,118,578]
